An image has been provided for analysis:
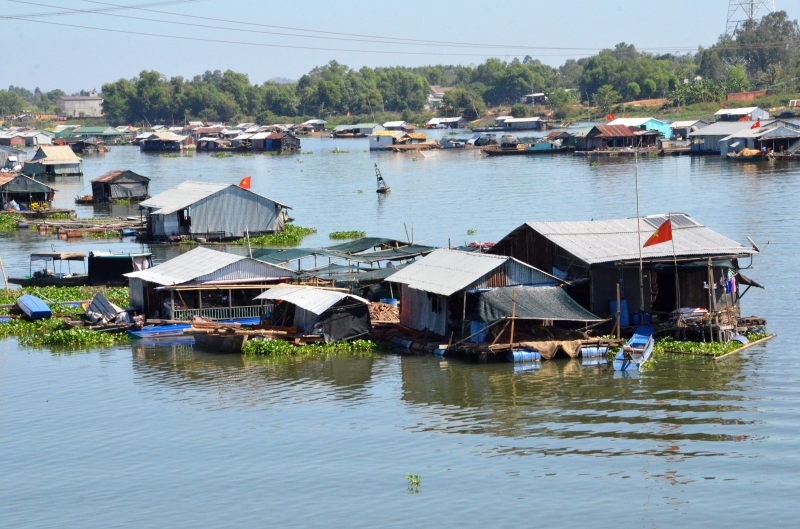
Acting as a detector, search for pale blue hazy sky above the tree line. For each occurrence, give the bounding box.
[0,0,788,92]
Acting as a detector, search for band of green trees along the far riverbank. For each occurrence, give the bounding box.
[7,11,800,127]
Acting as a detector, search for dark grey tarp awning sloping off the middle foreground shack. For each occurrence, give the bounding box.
[472,286,601,323]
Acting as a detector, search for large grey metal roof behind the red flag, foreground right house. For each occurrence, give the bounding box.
[527,213,757,264]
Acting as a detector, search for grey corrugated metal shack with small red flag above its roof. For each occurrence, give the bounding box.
[139,182,291,240]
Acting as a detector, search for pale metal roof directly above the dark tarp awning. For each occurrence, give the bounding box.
[387,248,558,296]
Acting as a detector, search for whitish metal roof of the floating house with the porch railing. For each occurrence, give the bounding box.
[125,246,294,285]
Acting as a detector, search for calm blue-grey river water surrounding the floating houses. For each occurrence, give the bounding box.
[0,138,800,528]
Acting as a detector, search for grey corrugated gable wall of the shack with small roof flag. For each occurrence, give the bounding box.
[190,186,283,237]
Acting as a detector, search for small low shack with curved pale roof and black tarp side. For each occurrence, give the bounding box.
[256,287,372,343]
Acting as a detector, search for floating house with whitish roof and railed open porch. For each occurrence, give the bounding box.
[125,247,294,320]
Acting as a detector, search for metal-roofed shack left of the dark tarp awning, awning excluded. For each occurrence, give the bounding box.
[387,248,560,336]
